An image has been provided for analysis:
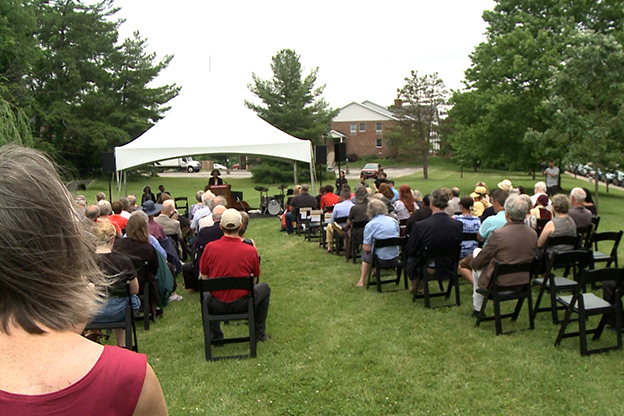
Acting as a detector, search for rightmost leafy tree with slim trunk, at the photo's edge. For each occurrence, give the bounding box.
[533,30,624,210]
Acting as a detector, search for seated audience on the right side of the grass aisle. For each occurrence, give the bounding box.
[285,174,614,322]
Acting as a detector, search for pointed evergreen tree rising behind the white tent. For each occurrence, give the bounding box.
[245,49,338,144]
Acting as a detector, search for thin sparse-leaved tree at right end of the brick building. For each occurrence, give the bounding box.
[389,71,448,179]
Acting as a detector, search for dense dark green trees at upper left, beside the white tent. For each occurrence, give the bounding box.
[0,0,180,173]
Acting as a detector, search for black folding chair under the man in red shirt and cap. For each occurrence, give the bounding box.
[199,275,256,361]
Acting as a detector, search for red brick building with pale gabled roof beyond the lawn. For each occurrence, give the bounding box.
[331,101,396,157]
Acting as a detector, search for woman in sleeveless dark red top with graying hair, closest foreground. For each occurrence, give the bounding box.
[0,146,167,415]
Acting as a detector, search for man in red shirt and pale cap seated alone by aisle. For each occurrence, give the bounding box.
[199,209,271,341]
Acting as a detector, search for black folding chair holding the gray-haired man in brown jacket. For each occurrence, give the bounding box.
[475,261,537,335]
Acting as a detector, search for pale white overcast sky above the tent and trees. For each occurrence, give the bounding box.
[108,0,495,108]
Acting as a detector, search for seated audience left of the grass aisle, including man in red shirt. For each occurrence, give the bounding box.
[75,180,270,346]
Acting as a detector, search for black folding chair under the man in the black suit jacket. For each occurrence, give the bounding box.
[412,244,461,308]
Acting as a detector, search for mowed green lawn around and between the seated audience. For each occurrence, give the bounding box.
[80,161,624,415]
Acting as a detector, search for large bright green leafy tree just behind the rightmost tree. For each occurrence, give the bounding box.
[449,0,624,170]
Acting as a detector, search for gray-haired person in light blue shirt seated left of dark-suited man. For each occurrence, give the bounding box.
[357,199,399,287]
